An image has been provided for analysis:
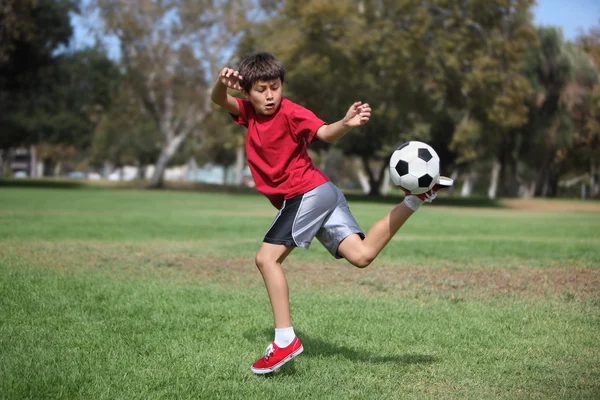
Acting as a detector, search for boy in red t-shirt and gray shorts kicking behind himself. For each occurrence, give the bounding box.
[211,53,452,374]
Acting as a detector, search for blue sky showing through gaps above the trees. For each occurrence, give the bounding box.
[72,0,600,60]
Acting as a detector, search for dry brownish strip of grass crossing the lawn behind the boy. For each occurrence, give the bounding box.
[5,240,600,300]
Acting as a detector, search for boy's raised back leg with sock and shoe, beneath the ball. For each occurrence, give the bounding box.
[338,176,454,268]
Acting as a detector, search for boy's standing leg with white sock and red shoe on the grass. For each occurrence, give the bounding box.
[252,243,303,374]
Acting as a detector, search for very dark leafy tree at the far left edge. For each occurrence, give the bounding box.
[0,0,77,149]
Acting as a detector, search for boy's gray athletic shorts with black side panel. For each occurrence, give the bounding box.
[263,182,365,258]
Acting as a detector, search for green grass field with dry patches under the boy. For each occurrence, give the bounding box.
[0,187,600,399]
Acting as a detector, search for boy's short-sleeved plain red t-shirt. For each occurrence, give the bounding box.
[232,98,329,209]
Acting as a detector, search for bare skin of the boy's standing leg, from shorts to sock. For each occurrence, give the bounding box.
[256,243,294,328]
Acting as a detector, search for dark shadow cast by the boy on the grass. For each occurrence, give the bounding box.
[244,329,438,375]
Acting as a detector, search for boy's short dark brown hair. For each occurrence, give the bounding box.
[238,52,285,92]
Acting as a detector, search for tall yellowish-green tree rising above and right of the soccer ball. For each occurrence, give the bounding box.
[429,0,536,197]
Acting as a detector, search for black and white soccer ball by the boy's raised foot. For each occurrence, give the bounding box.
[390,141,440,194]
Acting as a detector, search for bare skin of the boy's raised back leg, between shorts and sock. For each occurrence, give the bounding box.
[338,203,414,268]
